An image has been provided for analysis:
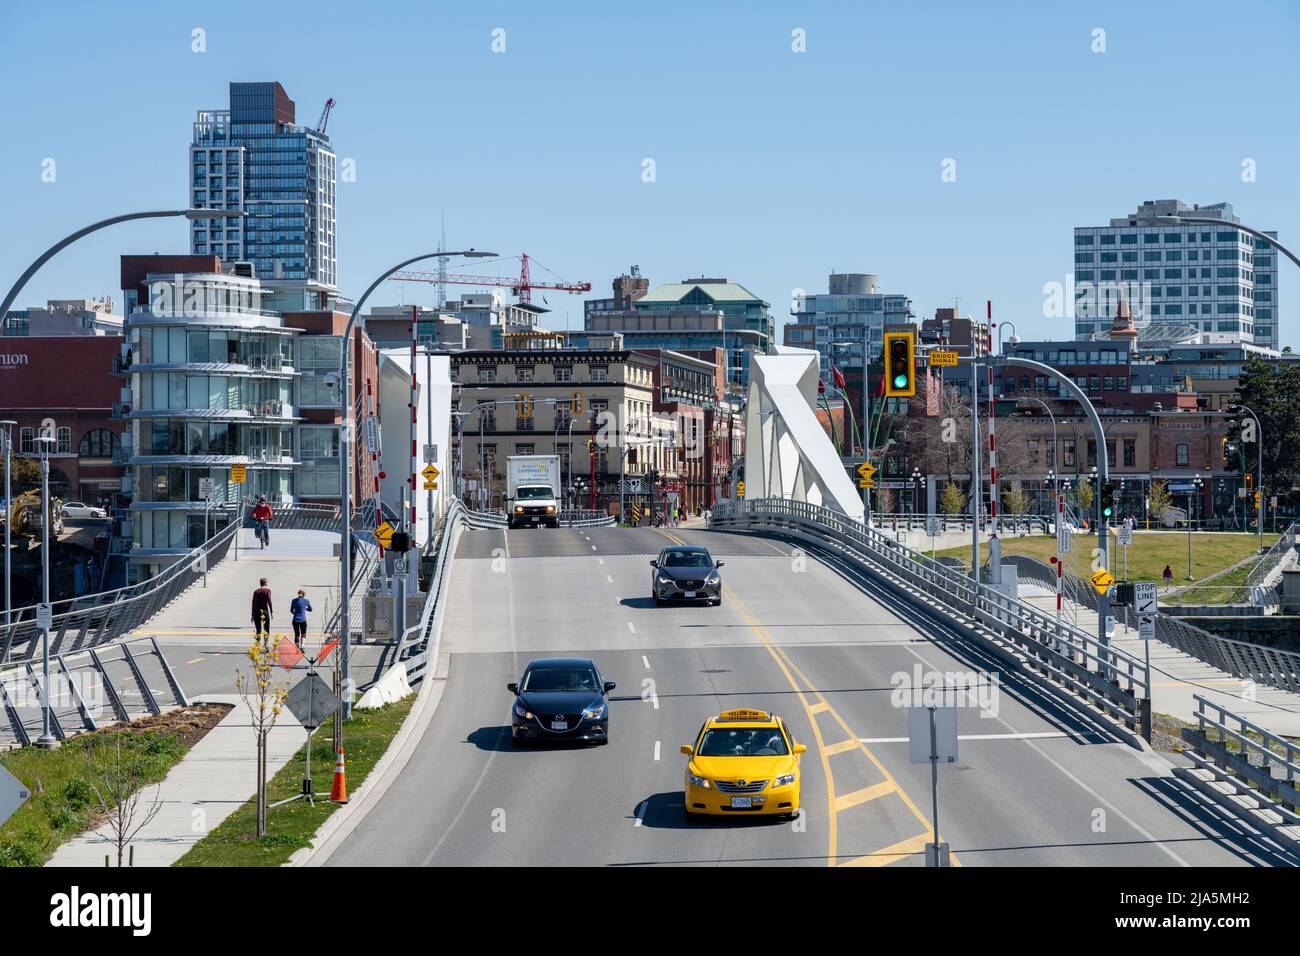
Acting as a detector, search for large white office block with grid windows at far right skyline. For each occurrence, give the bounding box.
[1074,199,1278,349]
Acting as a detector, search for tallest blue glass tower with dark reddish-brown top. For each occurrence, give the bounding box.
[190,82,337,287]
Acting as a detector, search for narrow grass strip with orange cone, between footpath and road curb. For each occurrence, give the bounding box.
[174,693,417,866]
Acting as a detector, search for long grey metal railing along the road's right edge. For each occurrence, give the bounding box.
[710,498,1151,737]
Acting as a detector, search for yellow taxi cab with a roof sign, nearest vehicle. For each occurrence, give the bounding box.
[681,708,807,817]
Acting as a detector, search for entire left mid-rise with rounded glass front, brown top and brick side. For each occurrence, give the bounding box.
[112,256,379,578]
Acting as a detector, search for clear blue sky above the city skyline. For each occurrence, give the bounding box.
[0,0,1300,346]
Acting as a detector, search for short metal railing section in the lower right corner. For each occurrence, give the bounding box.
[1174,695,1300,853]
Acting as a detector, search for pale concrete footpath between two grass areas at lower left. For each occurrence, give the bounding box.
[47,695,305,866]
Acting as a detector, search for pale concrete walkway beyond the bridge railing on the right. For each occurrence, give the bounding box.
[1021,583,1300,737]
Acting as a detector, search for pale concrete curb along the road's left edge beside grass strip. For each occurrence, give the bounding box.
[282,530,456,866]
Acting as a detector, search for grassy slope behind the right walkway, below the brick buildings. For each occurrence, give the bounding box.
[937,529,1277,590]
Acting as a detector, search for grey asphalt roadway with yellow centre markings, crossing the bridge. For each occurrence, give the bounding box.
[317,528,1289,866]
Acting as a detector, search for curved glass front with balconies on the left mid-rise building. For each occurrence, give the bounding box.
[120,267,299,578]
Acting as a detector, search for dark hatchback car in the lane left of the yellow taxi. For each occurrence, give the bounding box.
[506,657,615,747]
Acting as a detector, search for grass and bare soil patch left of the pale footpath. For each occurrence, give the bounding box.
[0,705,230,866]
